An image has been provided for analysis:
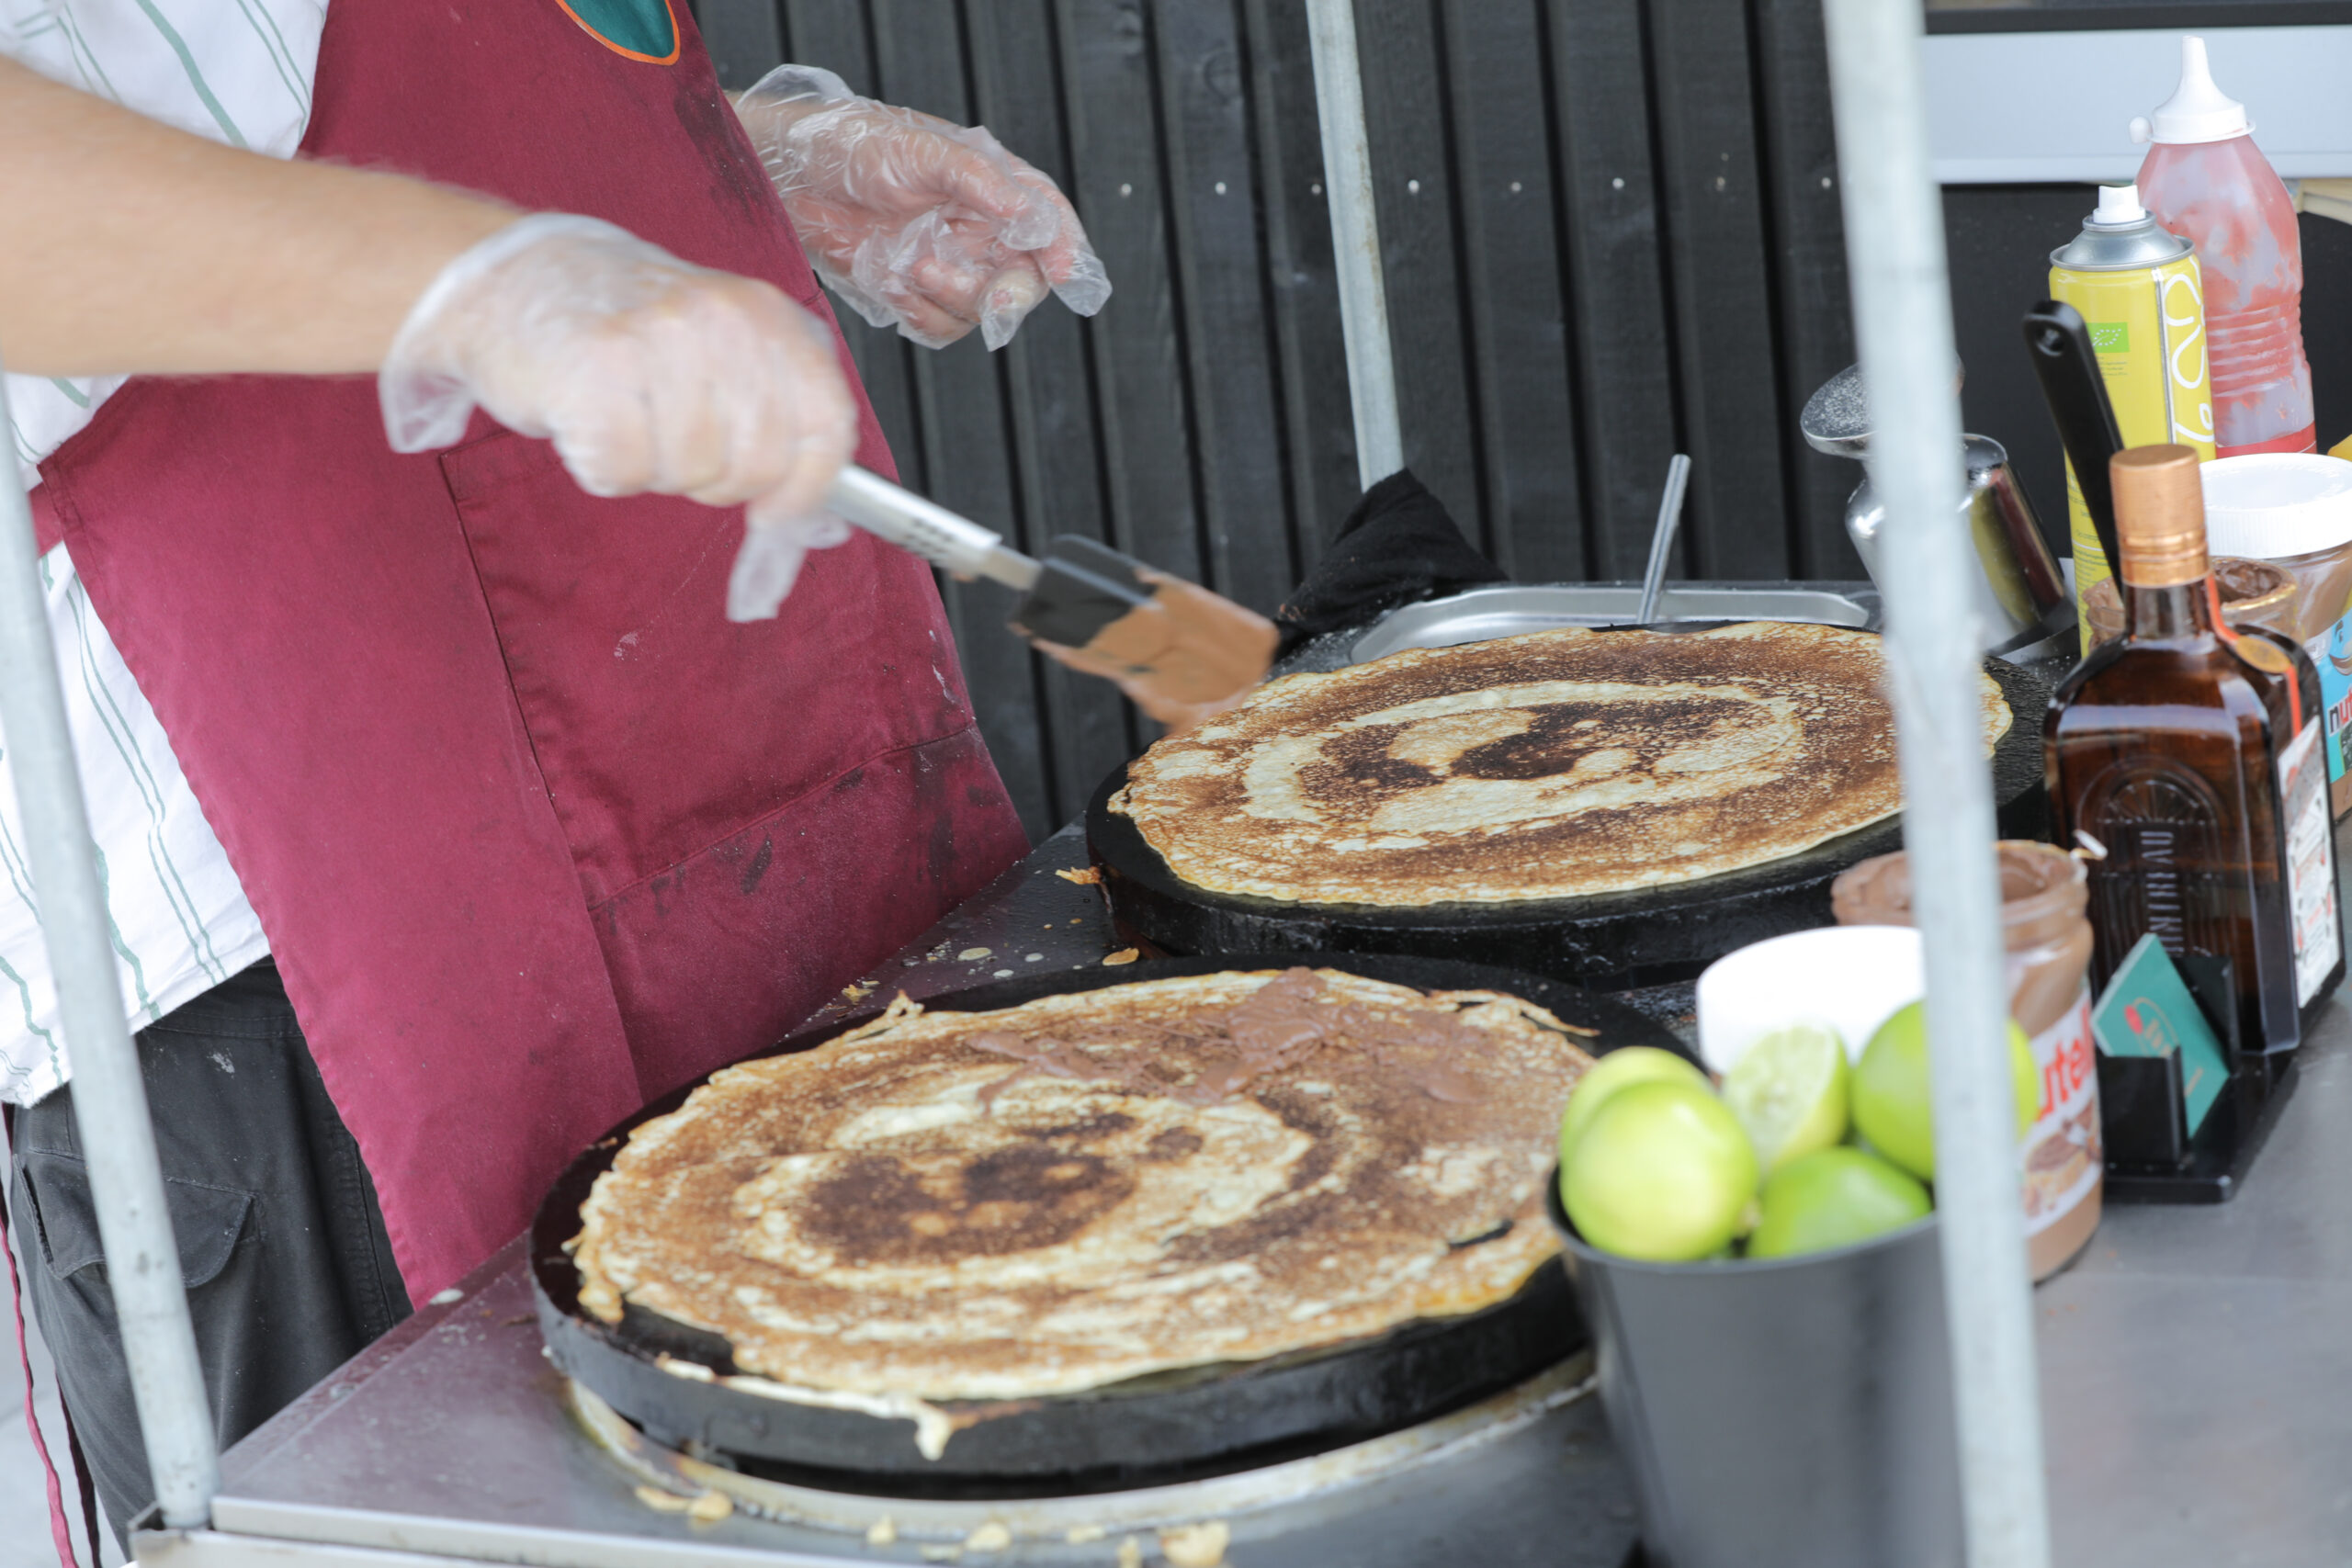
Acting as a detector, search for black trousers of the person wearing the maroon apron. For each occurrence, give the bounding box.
[12,959,409,1535]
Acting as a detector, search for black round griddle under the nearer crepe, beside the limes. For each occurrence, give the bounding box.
[532,952,1689,1497]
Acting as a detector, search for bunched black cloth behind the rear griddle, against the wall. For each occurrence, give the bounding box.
[1275,468,1510,651]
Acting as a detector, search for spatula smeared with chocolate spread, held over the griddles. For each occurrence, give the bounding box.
[826,468,1277,728]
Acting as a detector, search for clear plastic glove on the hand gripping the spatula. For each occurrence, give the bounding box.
[377,214,858,621]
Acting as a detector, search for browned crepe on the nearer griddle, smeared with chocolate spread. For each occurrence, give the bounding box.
[574,968,1590,1413]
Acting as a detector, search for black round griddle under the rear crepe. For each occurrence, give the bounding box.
[1087,639,2051,989]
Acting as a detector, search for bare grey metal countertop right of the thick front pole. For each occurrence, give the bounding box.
[2037,991,2352,1568]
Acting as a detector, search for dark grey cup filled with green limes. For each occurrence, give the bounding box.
[1553,982,2034,1568]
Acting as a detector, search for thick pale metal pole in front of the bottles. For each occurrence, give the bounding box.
[1823,0,2049,1568]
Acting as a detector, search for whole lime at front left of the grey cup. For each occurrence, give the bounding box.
[1559,1079,1757,1262]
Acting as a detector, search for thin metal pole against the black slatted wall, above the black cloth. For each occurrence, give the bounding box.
[1307,0,1404,489]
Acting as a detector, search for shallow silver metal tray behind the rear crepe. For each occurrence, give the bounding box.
[1352,583,1879,663]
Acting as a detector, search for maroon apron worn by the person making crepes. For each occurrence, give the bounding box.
[35,0,1025,1300]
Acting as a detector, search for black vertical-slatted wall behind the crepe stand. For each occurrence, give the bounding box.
[698,0,1860,832]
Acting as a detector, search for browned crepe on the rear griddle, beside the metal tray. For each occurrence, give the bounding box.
[1110,621,2008,905]
